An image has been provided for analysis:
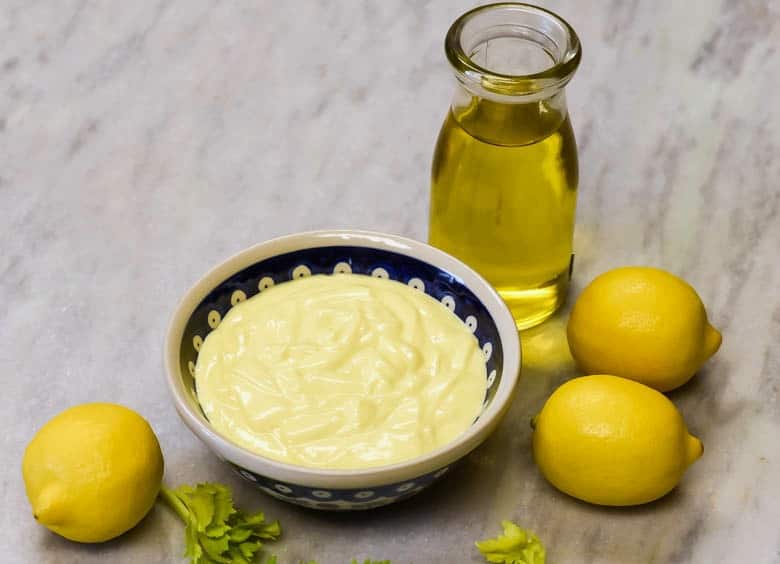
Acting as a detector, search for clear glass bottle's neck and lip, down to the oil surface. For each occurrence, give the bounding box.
[445,2,581,146]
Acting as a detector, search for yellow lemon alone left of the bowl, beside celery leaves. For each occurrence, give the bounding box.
[22,403,163,542]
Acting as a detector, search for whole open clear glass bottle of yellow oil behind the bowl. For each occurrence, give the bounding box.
[429,3,581,329]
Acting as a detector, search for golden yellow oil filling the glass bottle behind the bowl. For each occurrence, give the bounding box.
[429,97,578,329]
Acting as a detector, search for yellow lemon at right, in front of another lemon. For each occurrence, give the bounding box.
[533,376,703,505]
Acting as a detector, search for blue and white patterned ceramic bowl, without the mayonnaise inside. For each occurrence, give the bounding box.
[164,230,520,510]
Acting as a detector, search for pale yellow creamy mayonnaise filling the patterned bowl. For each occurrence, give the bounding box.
[195,274,486,469]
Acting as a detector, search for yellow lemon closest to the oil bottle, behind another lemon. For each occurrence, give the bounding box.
[567,267,721,392]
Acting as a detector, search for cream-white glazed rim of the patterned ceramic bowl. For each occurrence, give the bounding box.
[163,229,522,489]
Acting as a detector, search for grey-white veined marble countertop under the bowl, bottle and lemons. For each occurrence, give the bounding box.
[0,0,780,564]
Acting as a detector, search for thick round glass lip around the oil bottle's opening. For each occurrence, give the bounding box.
[444,2,582,97]
